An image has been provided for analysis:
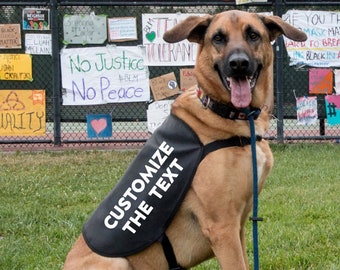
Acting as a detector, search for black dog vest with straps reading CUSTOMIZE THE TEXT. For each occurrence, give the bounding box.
[83,98,262,270]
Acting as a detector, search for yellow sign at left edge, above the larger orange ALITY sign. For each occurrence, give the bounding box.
[0,54,33,81]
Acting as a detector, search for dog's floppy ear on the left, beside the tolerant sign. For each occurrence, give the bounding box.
[163,15,212,43]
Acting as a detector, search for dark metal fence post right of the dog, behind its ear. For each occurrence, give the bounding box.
[274,0,284,143]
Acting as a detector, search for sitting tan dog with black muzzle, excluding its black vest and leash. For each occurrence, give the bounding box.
[64,11,306,270]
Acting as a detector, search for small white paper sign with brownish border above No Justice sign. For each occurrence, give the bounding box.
[108,17,137,42]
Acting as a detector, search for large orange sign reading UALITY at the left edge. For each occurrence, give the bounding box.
[0,90,46,136]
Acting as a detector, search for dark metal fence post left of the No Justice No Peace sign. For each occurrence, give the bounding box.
[50,0,61,146]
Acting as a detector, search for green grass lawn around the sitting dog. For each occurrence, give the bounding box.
[0,144,340,270]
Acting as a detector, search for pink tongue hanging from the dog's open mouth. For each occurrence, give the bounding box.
[230,79,251,108]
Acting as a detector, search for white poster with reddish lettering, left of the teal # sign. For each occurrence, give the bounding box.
[296,97,318,125]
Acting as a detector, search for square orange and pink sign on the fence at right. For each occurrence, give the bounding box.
[309,68,333,94]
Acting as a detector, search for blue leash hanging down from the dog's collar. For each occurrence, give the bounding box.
[248,110,263,270]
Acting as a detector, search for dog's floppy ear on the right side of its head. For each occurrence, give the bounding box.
[260,16,307,41]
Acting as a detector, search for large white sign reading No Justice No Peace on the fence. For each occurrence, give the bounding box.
[61,46,150,105]
